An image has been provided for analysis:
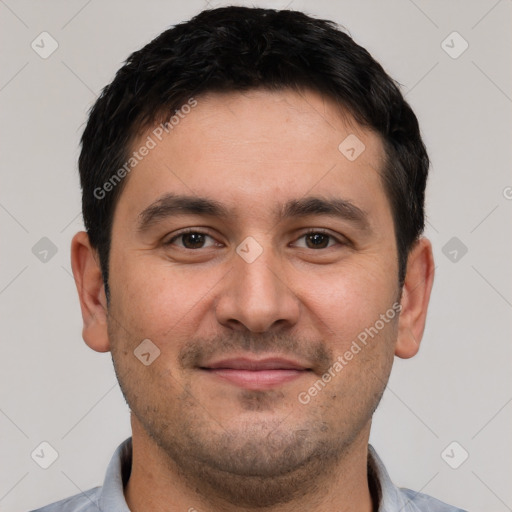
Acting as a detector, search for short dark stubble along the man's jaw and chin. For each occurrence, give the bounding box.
[109,323,391,509]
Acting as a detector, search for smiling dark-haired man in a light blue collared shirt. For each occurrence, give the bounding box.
[33,7,468,512]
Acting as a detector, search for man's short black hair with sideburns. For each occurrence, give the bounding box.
[79,6,429,298]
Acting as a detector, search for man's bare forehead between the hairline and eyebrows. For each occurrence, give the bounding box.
[115,90,384,222]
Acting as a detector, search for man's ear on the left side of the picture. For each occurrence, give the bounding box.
[71,231,110,352]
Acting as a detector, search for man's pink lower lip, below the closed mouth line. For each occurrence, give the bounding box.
[206,368,309,389]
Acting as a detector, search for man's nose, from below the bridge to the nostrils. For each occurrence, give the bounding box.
[215,243,300,333]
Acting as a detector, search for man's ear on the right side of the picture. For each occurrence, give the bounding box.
[395,238,434,359]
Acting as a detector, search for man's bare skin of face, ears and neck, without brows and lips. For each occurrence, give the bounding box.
[72,90,434,512]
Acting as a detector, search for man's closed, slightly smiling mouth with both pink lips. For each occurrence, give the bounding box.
[199,358,312,390]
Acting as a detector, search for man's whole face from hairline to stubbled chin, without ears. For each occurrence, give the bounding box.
[108,90,400,500]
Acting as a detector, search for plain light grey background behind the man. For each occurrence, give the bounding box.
[0,0,512,512]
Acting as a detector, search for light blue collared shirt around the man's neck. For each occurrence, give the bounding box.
[32,438,465,512]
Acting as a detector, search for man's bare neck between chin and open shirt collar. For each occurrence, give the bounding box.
[125,417,377,512]
